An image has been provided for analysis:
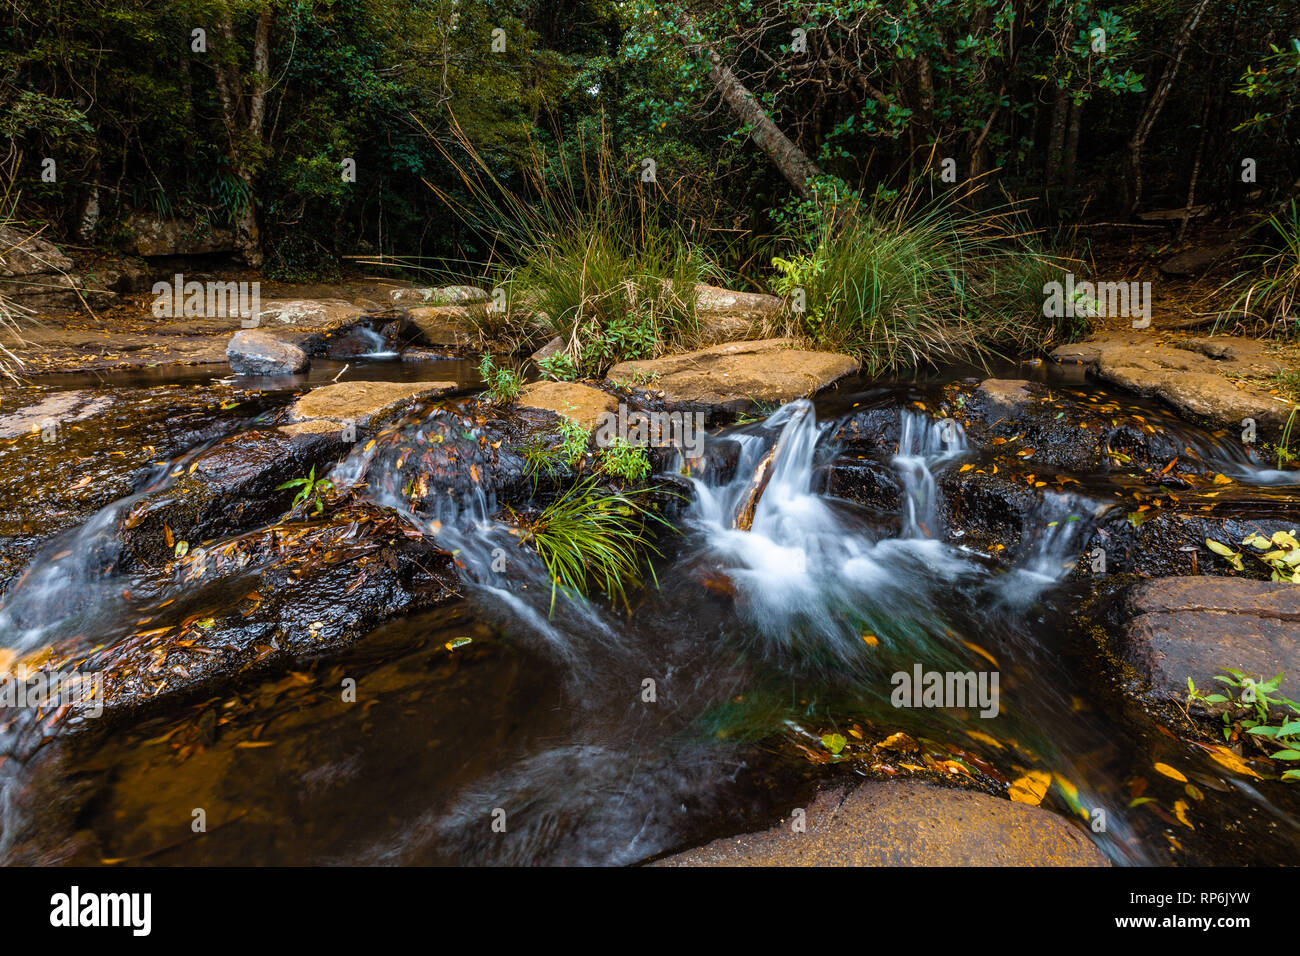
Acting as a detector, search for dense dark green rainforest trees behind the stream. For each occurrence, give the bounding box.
[0,0,1300,280]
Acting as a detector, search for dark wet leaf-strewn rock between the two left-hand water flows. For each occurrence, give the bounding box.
[85,505,456,723]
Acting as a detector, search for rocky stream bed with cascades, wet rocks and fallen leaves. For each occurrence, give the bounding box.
[0,295,1300,865]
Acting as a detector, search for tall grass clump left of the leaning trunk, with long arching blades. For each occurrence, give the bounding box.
[428,117,718,377]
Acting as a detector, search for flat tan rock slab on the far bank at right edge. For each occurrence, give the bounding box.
[1052,330,1292,438]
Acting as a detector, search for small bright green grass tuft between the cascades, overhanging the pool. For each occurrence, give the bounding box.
[514,476,671,613]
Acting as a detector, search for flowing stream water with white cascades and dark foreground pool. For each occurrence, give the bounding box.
[0,369,1300,864]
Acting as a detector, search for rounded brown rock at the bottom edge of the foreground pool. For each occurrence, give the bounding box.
[654,782,1108,866]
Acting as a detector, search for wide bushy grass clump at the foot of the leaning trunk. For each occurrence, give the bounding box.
[772,180,1075,373]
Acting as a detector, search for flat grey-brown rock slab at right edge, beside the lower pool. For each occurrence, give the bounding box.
[1121,576,1300,700]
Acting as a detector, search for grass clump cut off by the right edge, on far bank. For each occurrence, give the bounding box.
[1214,199,1300,337]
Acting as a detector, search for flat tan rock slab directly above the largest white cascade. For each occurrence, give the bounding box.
[606,338,859,414]
